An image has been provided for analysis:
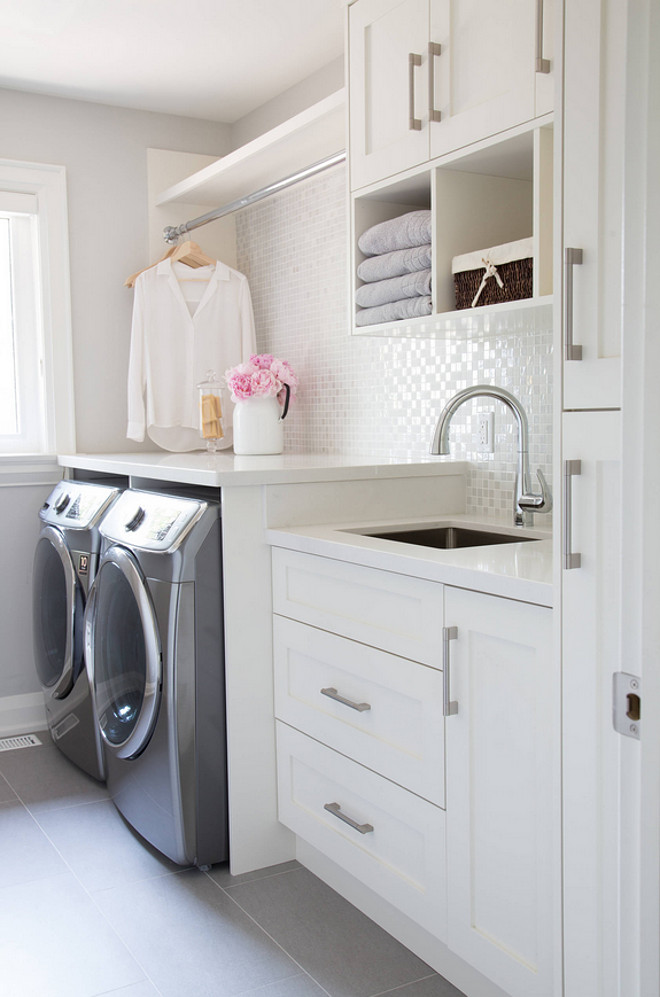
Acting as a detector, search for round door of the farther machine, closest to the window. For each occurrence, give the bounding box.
[32,526,85,699]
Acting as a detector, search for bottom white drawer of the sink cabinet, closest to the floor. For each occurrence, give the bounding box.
[277,722,446,938]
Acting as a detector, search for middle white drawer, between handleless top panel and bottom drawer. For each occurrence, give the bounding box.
[273,616,444,806]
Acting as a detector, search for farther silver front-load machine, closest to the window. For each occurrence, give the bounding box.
[32,481,120,781]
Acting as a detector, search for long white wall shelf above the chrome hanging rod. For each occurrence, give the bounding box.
[156,89,346,207]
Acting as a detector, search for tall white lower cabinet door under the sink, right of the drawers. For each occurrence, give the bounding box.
[445,587,561,997]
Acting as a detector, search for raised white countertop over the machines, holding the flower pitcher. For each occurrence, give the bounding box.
[57,450,468,488]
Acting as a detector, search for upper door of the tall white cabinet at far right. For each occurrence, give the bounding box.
[563,0,626,409]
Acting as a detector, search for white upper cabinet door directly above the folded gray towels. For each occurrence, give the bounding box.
[348,0,429,190]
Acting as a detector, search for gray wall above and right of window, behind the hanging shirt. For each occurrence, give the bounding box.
[0,90,230,454]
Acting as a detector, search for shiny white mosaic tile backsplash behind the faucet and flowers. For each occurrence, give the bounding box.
[236,166,552,527]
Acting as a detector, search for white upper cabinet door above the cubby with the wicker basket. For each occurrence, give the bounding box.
[429,0,536,158]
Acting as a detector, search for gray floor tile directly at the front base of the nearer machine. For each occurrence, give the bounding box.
[37,800,180,893]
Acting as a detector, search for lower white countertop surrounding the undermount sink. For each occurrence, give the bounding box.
[266,515,552,606]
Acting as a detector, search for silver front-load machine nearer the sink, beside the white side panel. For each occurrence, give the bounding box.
[85,489,228,867]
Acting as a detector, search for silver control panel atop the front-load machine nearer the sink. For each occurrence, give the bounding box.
[99,488,207,554]
